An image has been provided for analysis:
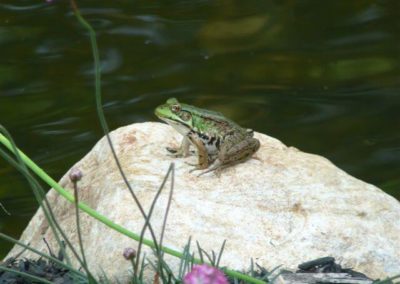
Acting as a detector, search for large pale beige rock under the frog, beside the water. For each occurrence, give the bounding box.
[8,123,400,280]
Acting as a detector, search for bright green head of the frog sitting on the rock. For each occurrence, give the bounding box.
[154,98,193,135]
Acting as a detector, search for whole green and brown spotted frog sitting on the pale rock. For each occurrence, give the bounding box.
[154,98,260,176]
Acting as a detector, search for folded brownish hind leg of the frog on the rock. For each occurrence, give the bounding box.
[199,137,260,176]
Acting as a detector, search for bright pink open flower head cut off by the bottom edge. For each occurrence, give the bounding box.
[183,264,228,284]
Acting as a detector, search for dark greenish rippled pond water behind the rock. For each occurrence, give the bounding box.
[0,0,400,258]
